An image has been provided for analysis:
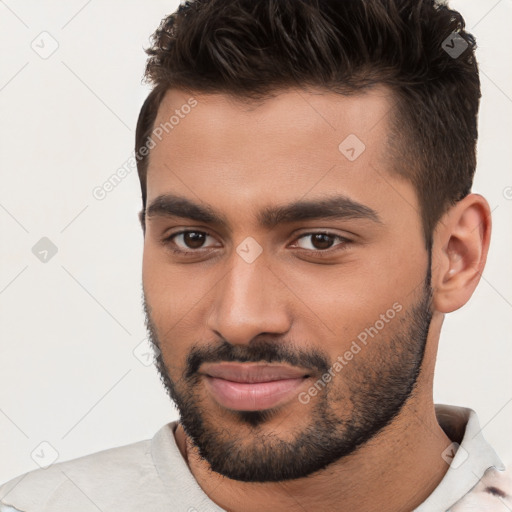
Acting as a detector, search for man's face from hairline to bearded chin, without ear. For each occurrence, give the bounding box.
[143,88,432,482]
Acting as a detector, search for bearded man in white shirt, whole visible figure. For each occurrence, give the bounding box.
[0,0,512,512]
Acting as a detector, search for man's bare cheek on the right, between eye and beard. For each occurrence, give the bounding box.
[281,258,426,370]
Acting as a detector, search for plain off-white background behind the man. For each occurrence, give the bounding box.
[0,0,512,482]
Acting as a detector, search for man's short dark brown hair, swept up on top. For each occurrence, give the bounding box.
[135,0,481,248]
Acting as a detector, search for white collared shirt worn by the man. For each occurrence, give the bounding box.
[0,405,512,512]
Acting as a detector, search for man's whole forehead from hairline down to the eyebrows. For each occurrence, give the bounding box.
[147,87,415,230]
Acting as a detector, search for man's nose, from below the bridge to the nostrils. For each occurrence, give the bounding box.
[207,247,290,345]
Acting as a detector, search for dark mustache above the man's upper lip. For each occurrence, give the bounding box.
[184,340,329,379]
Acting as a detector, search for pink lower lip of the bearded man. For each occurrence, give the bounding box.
[206,375,308,411]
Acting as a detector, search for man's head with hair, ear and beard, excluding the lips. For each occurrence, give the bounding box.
[136,0,490,481]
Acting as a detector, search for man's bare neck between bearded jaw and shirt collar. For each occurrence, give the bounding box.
[176,400,451,512]
